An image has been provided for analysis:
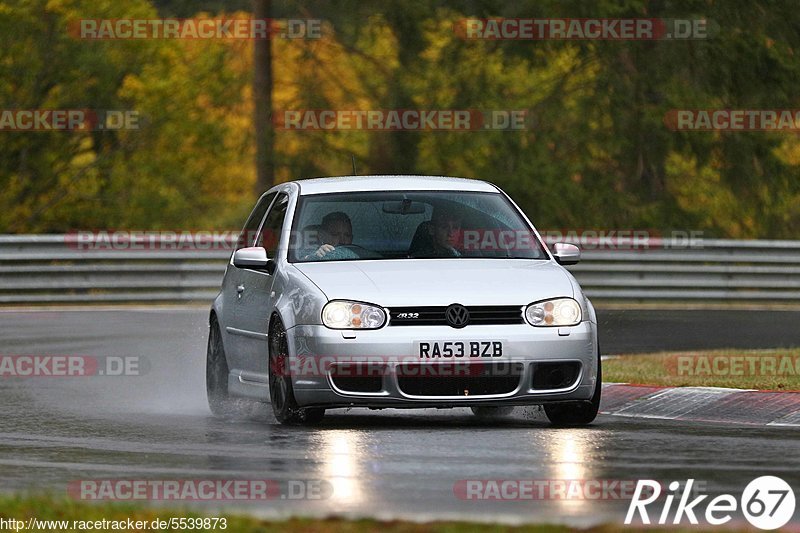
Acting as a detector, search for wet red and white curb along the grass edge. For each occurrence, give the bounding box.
[600,383,800,427]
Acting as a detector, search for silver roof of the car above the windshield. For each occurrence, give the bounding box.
[293,175,497,195]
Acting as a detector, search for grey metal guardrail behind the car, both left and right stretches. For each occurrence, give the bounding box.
[0,235,800,304]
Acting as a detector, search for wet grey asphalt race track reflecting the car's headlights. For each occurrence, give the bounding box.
[0,309,800,526]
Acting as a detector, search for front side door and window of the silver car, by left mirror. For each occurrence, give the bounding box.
[234,193,289,383]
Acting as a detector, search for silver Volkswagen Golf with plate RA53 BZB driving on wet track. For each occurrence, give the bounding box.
[206,176,601,425]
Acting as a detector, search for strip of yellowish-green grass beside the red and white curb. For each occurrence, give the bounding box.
[603,348,800,391]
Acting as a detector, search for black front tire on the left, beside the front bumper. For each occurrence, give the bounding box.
[269,317,325,424]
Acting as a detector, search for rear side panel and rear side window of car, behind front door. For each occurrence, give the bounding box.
[220,192,276,374]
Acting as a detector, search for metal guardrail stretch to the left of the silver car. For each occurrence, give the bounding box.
[0,235,230,304]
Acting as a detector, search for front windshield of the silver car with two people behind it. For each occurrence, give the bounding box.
[289,191,548,262]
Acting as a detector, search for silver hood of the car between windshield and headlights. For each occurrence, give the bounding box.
[294,259,574,307]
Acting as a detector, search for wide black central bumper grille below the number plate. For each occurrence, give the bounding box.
[397,363,524,397]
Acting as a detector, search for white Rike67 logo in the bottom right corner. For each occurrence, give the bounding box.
[625,476,795,530]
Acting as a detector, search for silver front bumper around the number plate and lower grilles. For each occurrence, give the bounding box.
[287,321,598,408]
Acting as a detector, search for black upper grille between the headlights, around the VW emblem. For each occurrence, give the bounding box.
[389,305,525,326]
